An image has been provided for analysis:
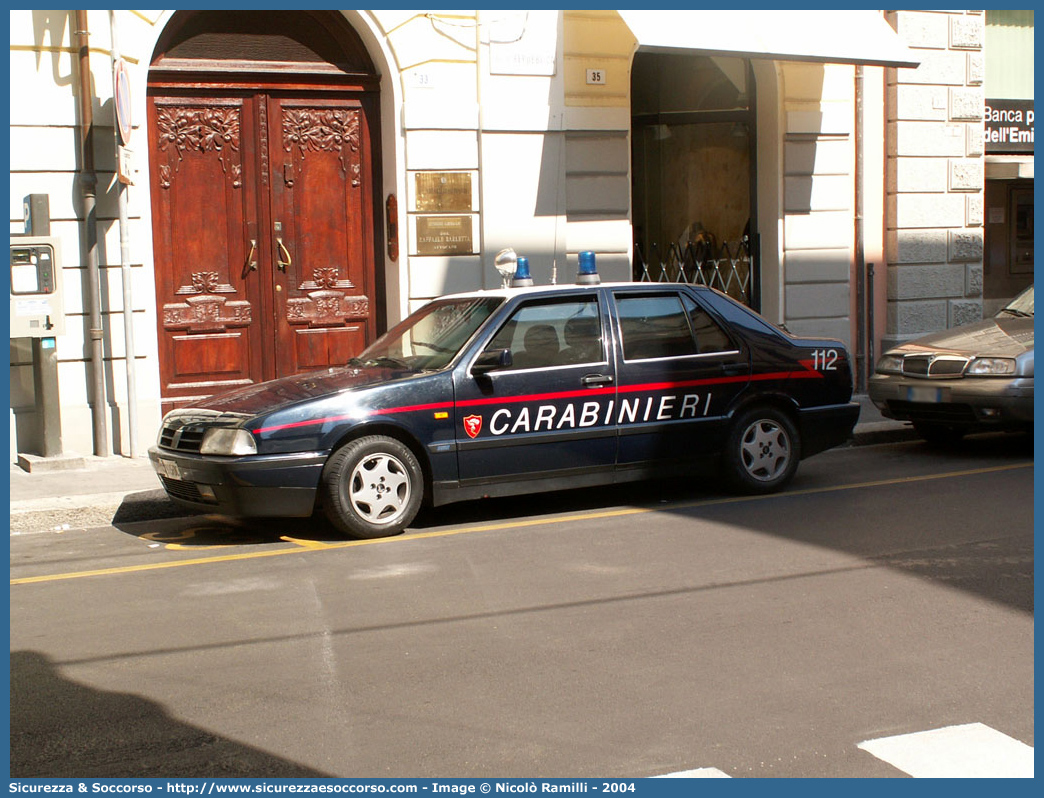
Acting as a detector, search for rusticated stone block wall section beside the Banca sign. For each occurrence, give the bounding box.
[882,11,986,347]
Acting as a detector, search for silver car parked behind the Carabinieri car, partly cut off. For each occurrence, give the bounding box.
[870,286,1034,443]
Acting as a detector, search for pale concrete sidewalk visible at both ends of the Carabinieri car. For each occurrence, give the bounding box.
[10,396,916,534]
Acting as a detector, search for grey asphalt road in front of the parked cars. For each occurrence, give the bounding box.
[10,437,1034,777]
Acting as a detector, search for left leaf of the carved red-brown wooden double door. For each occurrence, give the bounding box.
[149,91,263,410]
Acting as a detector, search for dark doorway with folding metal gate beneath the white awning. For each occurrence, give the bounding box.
[631,52,760,309]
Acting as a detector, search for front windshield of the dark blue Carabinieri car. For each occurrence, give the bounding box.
[349,297,503,371]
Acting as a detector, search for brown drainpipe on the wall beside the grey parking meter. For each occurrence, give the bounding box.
[74,10,109,457]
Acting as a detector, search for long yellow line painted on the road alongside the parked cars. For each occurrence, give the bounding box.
[10,463,1034,586]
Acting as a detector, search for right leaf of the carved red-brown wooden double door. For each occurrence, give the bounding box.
[268,97,375,374]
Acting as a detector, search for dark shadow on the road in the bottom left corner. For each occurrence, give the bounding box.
[10,651,328,778]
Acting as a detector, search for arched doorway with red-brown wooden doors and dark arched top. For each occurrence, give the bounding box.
[148,11,385,412]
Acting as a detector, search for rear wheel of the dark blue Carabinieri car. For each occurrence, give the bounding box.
[725,406,801,494]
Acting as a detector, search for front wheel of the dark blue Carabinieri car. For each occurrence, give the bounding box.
[322,436,424,540]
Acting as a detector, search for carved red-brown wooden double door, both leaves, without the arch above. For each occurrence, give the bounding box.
[148,88,381,412]
